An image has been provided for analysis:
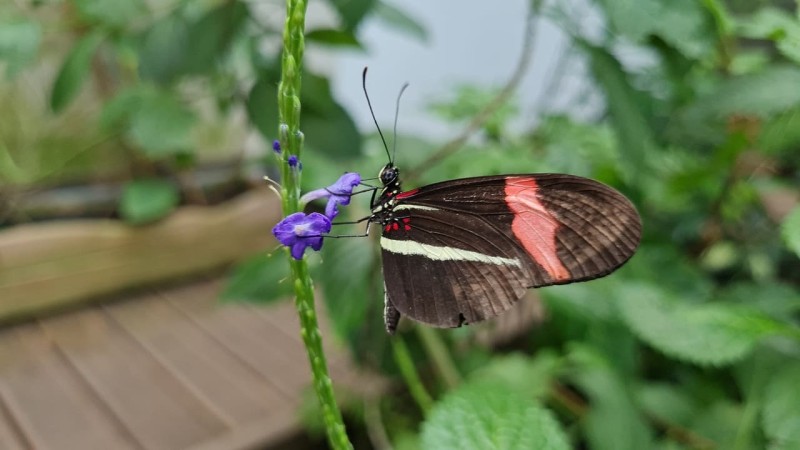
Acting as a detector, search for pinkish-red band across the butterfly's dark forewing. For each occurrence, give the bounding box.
[505,177,571,281]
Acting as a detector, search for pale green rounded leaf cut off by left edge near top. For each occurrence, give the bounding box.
[0,17,42,77]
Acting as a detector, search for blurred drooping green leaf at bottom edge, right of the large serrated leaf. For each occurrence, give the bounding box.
[567,343,652,450]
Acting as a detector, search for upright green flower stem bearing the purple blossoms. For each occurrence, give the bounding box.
[278,0,353,450]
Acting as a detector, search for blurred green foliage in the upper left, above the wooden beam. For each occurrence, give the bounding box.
[0,0,418,223]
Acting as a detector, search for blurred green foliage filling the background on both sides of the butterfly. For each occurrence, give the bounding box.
[6,0,800,450]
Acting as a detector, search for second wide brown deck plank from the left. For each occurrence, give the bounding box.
[42,310,228,449]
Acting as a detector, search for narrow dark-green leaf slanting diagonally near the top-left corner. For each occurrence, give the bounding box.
[50,33,103,112]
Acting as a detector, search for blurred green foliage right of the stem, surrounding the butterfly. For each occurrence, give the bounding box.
[231,0,800,450]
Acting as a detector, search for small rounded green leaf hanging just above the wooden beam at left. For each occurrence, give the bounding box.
[119,179,180,225]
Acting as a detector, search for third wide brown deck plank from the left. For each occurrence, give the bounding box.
[106,291,297,428]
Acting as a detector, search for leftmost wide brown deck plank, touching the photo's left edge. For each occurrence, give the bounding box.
[0,325,141,450]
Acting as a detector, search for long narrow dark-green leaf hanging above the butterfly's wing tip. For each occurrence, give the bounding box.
[582,42,656,180]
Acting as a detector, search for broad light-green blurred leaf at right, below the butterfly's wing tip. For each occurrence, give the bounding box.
[617,283,785,366]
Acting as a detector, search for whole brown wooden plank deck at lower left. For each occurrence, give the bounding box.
[0,281,372,450]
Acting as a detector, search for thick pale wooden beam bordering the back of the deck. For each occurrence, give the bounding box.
[0,188,281,319]
